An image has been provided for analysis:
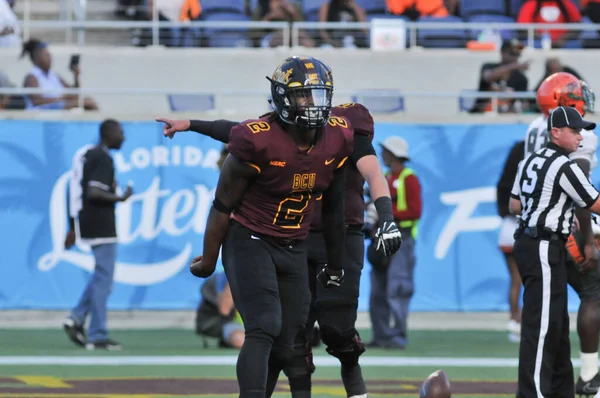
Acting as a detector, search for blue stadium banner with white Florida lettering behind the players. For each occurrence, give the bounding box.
[0,121,597,311]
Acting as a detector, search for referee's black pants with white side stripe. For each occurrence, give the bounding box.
[514,235,575,398]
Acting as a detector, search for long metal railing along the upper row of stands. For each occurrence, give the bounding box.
[14,18,600,48]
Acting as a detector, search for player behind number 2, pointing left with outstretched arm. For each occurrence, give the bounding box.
[156,98,401,398]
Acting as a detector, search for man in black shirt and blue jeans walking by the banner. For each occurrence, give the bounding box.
[63,119,133,350]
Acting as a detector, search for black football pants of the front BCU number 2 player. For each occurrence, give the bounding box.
[223,221,310,398]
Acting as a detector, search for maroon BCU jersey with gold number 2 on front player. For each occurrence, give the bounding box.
[229,117,354,239]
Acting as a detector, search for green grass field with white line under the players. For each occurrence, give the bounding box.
[0,329,579,398]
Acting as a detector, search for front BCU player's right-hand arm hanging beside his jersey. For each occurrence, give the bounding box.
[319,166,346,287]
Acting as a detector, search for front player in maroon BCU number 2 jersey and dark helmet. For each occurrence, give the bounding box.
[177,57,354,398]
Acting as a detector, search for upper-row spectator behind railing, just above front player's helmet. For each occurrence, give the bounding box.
[253,0,315,47]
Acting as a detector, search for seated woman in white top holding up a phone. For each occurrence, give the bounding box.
[21,39,98,111]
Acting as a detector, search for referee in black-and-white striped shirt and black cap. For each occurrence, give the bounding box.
[509,107,600,398]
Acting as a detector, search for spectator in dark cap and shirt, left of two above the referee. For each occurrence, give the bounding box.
[471,39,529,113]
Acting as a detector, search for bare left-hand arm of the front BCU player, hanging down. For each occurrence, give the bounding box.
[190,154,257,278]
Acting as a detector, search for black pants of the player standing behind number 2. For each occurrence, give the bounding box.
[286,226,367,398]
